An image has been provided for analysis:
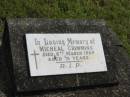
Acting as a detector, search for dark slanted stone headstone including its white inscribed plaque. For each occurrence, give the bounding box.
[3,19,121,96]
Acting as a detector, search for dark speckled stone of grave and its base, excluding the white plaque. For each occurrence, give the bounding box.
[3,19,129,97]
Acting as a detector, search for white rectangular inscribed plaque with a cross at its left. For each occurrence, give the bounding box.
[26,33,107,76]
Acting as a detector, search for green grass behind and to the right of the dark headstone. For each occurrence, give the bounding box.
[0,0,130,54]
